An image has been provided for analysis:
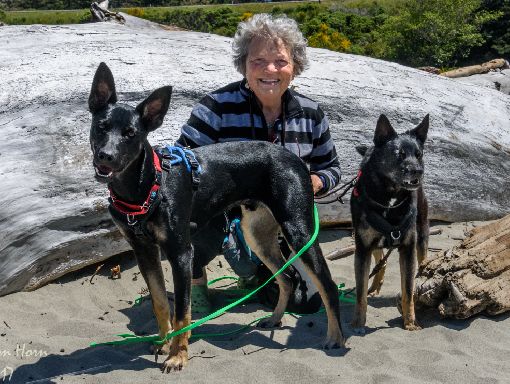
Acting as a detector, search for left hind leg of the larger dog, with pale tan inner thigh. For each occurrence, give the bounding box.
[241,205,292,328]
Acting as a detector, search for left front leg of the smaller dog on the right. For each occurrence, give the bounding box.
[351,235,371,335]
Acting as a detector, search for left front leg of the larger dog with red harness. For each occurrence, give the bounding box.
[130,240,172,354]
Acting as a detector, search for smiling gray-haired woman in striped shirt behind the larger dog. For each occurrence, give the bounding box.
[177,14,341,314]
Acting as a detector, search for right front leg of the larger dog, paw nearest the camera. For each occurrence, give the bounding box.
[161,244,193,373]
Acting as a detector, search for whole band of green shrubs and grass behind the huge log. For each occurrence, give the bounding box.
[0,0,504,67]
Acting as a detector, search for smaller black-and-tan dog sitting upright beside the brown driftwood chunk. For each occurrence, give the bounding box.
[351,115,429,334]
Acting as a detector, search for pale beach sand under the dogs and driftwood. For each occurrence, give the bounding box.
[0,223,510,384]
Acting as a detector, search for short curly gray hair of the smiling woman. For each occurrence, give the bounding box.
[232,13,308,76]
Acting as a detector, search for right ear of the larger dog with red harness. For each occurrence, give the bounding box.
[136,86,172,131]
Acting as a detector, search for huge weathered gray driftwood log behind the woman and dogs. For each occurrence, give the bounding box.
[0,20,510,295]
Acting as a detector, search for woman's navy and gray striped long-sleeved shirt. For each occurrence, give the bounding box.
[177,80,341,193]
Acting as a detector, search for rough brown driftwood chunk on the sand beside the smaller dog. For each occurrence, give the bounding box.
[416,215,510,319]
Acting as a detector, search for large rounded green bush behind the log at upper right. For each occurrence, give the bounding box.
[374,0,499,67]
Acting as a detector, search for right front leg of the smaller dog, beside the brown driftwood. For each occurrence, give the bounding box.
[398,243,421,331]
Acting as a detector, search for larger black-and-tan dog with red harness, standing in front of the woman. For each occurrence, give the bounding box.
[89,63,344,372]
